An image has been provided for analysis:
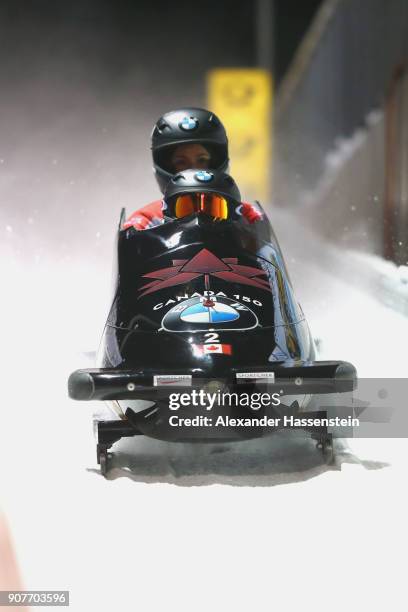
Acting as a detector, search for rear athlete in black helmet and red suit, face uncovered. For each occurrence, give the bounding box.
[124,107,262,229]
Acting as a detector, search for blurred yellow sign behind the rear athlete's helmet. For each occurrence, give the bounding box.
[207,68,272,204]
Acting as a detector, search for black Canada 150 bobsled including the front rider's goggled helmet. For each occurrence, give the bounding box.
[68,170,356,474]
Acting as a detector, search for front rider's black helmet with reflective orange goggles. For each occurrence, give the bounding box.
[163,170,241,220]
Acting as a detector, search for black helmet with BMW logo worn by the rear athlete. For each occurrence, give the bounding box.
[152,107,228,193]
